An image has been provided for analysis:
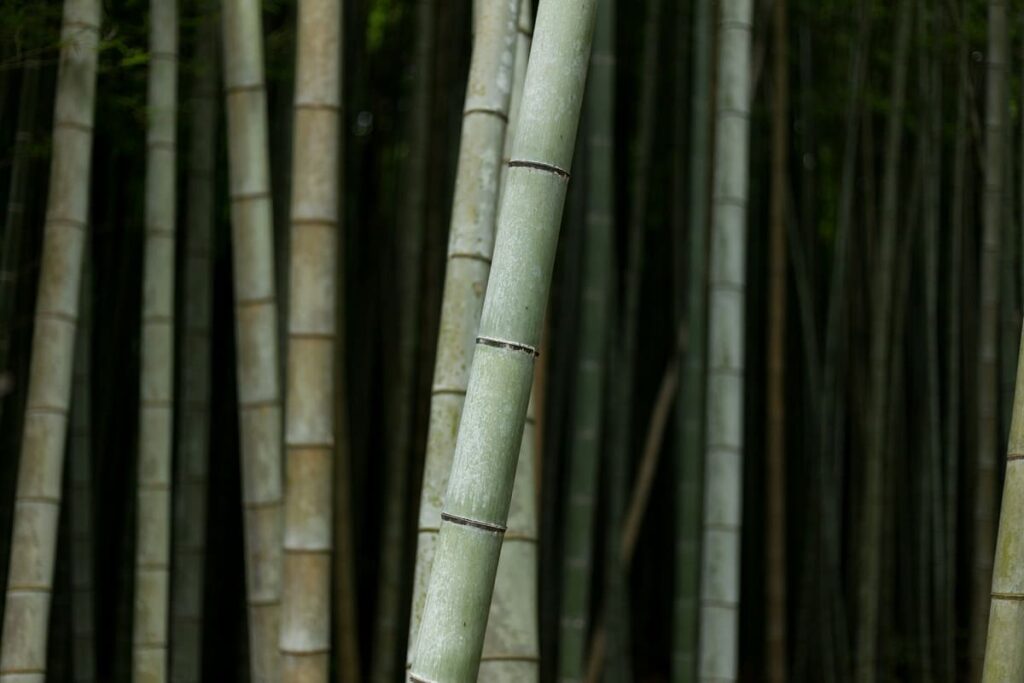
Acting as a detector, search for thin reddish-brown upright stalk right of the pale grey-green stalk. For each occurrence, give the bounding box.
[765,0,790,683]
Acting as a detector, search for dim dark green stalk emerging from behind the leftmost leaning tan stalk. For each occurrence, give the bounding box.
[68,258,96,683]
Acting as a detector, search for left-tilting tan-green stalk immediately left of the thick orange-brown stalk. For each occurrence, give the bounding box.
[222,0,282,683]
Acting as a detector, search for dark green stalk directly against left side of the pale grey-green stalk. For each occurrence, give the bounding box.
[672,0,714,683]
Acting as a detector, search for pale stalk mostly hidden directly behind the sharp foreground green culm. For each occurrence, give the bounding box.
[478,0,541,683]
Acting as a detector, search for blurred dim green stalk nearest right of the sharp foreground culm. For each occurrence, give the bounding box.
[558,0,615,682]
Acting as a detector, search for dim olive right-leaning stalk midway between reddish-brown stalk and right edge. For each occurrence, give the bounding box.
[856,0,913,683]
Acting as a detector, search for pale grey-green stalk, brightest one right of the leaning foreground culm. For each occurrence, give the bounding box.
[697,0,753,681]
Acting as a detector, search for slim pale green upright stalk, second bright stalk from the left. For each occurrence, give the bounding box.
[132,0,178,683]
